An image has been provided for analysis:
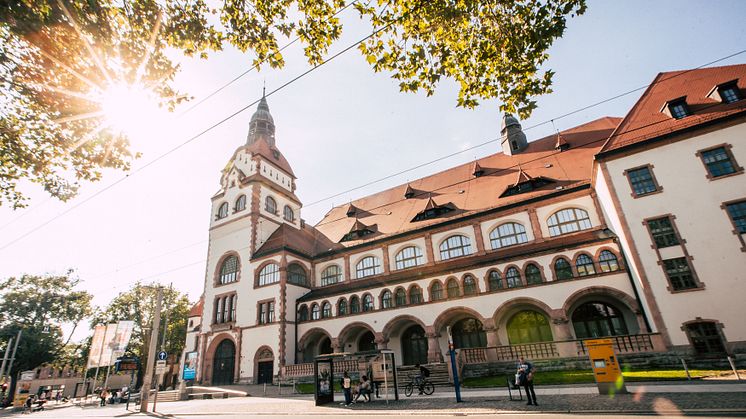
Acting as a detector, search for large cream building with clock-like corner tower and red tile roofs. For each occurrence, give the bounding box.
[187,66,746,384]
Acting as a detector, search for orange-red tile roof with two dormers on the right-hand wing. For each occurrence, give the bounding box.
[601,64,746,156]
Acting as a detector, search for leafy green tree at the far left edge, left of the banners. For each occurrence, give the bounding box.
[0,271,92,374]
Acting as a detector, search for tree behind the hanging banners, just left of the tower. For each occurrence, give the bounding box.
[91,282,190,386]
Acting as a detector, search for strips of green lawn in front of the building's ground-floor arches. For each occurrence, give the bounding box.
[463,370,730,388]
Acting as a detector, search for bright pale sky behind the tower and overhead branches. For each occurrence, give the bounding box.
[0,0,746,340]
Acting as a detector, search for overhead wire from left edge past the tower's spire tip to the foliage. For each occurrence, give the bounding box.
[0,15,402,251]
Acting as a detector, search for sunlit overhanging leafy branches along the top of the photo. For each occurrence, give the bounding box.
[0,0,586,207]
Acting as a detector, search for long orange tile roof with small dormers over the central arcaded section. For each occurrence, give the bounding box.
[310,117,620,247]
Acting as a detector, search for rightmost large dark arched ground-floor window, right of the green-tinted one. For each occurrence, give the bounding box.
[572,302,627,339]
